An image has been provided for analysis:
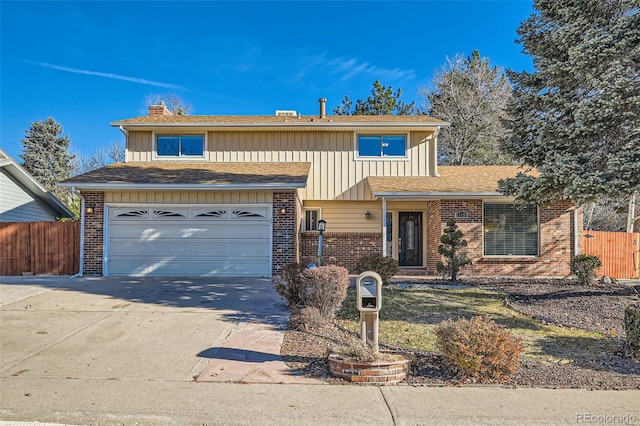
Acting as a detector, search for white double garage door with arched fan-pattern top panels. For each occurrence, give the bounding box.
[105,206,271,277]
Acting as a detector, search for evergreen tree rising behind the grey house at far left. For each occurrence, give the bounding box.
[19,117,74,203]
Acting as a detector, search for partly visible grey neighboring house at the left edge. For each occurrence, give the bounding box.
[0,149,74,222]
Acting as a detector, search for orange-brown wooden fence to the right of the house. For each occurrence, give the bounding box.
[584,230,640,278]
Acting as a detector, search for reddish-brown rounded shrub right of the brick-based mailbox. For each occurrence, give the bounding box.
[436,317,524,380]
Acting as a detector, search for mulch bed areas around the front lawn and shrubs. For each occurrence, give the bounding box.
[281,279,640,389]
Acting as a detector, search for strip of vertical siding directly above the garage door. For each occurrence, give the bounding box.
[104,191,273,204]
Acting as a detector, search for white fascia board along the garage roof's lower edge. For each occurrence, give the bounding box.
[58,182,307,191]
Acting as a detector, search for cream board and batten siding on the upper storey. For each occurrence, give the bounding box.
[127,129,435,200]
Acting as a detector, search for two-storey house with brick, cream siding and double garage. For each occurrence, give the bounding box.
[62,99,582,276]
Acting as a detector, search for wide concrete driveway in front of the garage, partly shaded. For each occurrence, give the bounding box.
[0,277,296,381]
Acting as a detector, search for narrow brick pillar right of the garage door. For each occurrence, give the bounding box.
[271,192,299,276]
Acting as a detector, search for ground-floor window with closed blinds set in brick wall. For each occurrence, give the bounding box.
[483,204,538,256]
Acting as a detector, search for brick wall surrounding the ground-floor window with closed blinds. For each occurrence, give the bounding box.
[438,200,582,276]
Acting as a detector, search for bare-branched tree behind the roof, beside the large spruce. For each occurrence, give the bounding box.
[419,50,513,166]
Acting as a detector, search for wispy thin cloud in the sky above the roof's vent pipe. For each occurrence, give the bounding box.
[298,54,416,81]
